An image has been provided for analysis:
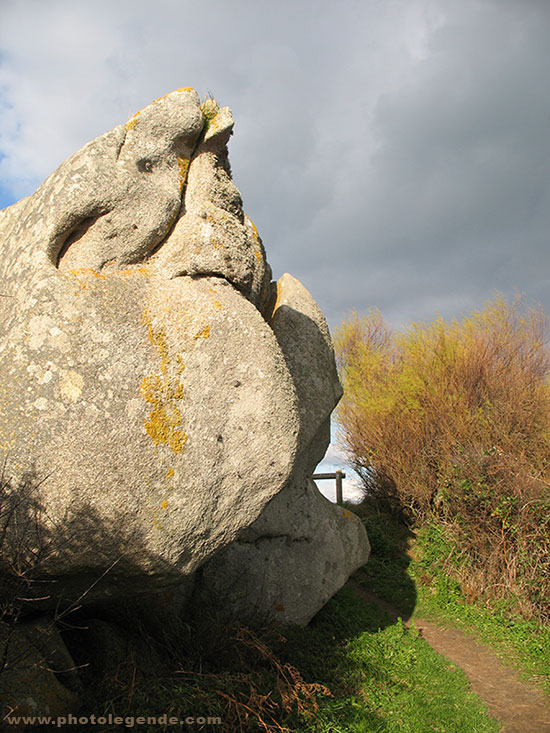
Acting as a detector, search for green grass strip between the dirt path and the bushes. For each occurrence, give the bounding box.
[356,507,550,694]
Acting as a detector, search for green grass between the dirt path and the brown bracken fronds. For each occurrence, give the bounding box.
[287,588,500,733]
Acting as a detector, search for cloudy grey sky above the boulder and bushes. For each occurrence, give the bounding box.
[0,0,550,498]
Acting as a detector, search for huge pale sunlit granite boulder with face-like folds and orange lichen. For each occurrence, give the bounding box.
[0,89,366,618]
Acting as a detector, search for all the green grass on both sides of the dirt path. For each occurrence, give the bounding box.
[75,506,550,733]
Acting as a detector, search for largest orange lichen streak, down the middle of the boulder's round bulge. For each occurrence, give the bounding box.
[140,310,187,453]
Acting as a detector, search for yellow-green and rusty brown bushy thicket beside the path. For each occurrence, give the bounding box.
[335,298,550,621]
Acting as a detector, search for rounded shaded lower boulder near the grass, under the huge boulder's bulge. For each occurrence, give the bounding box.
[193,478,370,626]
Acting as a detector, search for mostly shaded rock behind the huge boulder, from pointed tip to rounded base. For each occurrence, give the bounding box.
[198,274,370,624]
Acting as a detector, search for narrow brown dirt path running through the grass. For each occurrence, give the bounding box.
[350,583,550,733]
